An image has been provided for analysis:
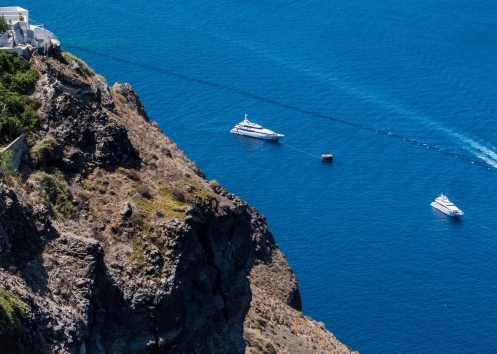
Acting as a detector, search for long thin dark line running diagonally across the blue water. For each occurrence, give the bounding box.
[67,44,497,172]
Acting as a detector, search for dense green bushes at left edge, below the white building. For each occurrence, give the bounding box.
[0,51,41,143]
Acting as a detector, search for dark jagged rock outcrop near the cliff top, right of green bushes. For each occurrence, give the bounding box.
[29,57,139,173]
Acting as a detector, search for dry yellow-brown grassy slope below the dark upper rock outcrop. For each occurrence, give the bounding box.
[36,82,217,266]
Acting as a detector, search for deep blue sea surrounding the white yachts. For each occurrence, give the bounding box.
[22,0,497,354]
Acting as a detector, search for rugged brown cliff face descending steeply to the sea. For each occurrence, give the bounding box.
[0,47,351,353]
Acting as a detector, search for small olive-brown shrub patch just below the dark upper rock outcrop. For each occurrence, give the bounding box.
[33,171,76,218]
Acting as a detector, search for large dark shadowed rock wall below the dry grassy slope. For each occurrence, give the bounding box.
[86,203,251,353]
